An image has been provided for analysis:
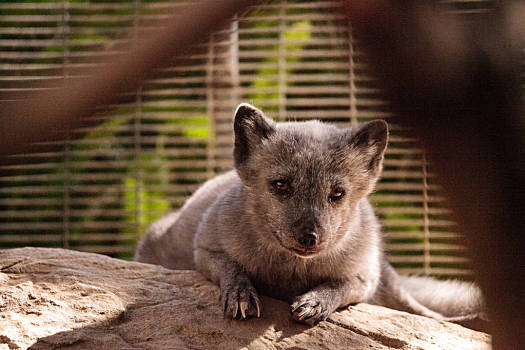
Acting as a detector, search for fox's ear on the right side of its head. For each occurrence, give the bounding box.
[350,120,388,172]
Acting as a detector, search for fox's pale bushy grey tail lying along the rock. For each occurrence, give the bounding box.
[375,263,488,330]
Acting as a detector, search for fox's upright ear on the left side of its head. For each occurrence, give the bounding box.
[233,103,275,167]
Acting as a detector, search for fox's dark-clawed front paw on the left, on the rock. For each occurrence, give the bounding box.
[220,277,261,319]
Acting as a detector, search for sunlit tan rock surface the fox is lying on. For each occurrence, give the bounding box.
[0,248,490,350]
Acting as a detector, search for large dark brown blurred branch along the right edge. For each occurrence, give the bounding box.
[344,0,525,349]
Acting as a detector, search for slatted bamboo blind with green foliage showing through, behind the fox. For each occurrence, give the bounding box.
[0,0,493,276]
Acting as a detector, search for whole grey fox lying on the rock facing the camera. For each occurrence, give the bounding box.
[135,104,483,323]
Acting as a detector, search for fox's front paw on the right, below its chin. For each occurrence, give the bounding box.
[290,291,333,325]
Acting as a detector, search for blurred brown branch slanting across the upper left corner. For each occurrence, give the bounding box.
[0,0,257,165]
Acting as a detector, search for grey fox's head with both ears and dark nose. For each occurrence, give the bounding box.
[234,103,388,257]
